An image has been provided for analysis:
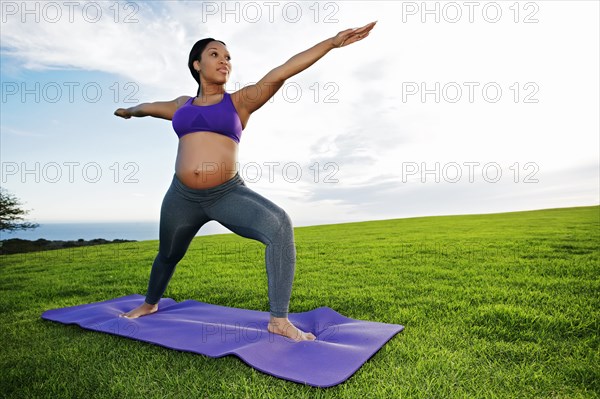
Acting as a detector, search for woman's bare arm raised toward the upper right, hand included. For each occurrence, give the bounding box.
[234,21,377,115]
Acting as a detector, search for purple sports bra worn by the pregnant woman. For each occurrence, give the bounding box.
[171,93,242,143]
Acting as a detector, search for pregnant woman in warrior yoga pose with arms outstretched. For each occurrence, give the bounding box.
[115,22,376,341]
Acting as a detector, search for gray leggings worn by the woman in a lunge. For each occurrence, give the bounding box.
[146,174,296,317]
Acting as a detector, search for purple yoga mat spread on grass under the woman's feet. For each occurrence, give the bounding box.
[42,294,404,387]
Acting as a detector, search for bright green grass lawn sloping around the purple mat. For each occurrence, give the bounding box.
[0,206,600,399]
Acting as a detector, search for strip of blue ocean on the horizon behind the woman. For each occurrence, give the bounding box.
[0,221,230,241]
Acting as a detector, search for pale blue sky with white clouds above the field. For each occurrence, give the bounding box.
[0,1,600,236]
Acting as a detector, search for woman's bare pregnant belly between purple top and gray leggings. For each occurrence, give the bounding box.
[175,132,238,189]
